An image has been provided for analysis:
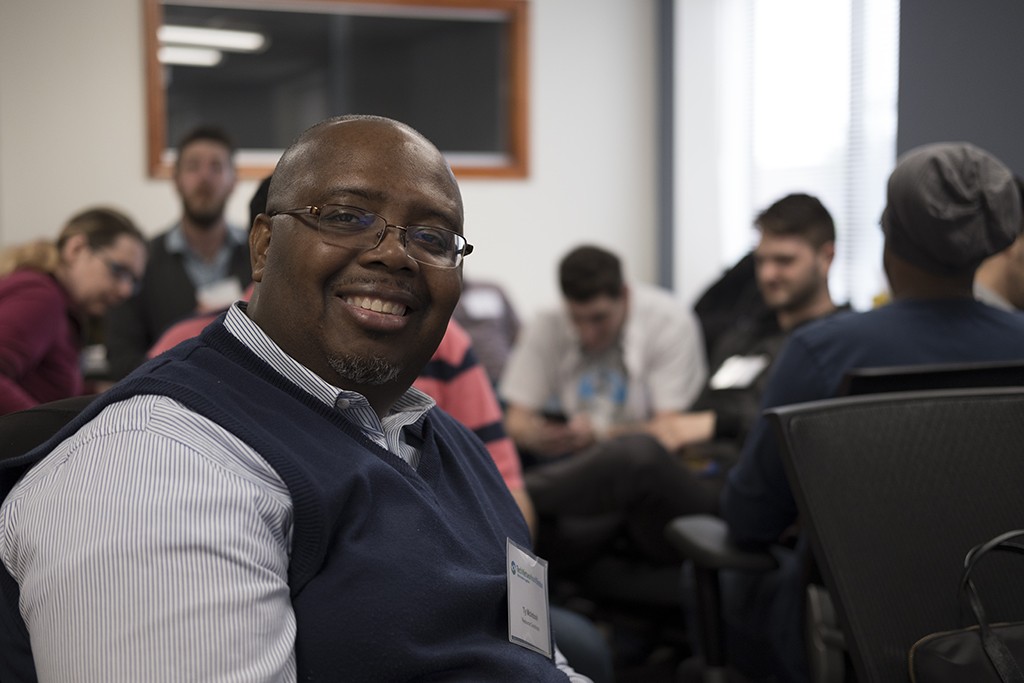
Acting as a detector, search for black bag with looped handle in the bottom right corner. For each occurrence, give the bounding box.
[909,529,1024,683]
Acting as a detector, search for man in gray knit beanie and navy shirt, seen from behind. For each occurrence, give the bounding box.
[721,142,1024,683]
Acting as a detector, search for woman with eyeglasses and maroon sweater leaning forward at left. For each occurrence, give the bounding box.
[0,208,146,415]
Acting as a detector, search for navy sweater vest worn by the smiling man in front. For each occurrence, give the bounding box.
[0,325,566,683]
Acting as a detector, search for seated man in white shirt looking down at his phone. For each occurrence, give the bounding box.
[499,246,717,574]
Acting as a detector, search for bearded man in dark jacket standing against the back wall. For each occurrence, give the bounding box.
[105,126,252,380]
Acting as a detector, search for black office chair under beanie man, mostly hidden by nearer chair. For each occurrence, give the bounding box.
[666,360,1024,683]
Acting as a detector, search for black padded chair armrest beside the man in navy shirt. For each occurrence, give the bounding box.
[665,515,778,571]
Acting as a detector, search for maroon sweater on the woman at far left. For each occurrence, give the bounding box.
[0,268,82,415]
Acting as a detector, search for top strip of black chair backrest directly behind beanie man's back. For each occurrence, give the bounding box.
[839,360,1024,396]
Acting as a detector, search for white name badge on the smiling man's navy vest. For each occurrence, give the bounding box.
[505,539,555,659]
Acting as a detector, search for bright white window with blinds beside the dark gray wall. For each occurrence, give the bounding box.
[674,0,900,309]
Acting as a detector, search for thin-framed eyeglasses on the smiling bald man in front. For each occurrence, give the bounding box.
[267,204,473,268]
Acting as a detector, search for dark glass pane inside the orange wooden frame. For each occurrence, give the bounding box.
[163,4,510,154]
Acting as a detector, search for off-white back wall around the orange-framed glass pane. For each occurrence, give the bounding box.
[0,0,656,323]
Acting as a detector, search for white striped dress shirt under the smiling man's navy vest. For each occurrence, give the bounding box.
[0,305,588,683]
